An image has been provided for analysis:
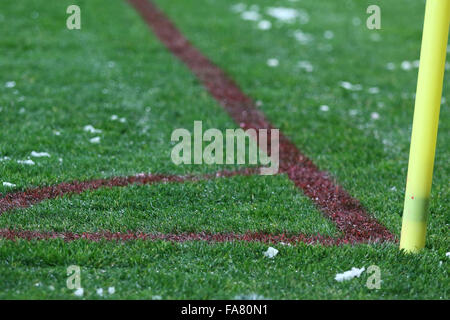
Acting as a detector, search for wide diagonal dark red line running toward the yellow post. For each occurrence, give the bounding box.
[128,0,395,242]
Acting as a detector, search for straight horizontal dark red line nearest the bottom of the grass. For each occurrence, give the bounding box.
[0,229,362,246]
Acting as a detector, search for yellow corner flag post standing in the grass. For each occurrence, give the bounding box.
[400,0,450,252]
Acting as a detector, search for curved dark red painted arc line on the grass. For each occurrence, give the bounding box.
[0,168,259,215]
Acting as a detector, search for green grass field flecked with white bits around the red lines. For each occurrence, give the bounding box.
[0,0,450,299]
